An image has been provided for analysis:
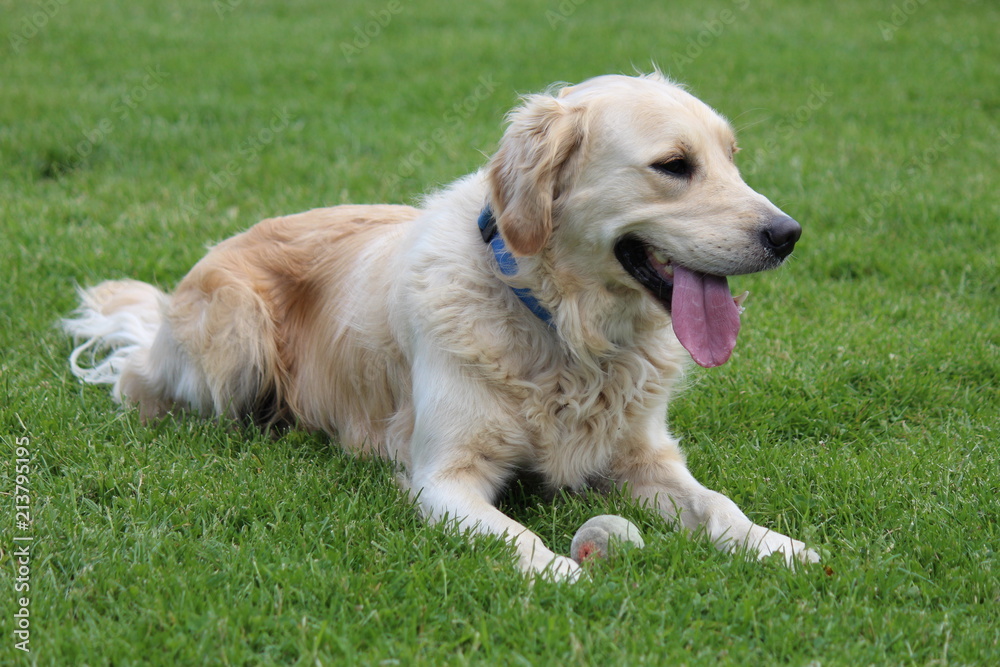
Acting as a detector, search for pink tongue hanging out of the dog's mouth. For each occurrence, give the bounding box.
[670,265,740,368]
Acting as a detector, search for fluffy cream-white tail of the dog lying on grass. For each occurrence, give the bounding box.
[62,280,170,402]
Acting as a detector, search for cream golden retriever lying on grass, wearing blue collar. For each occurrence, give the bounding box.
[65,73,818,580]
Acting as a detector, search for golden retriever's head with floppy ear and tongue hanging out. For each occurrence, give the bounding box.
[488,74,801,366]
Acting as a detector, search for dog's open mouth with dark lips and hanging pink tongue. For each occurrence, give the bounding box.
[615,235,746,368]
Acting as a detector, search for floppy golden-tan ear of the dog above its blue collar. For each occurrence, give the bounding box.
[487,95,582,256]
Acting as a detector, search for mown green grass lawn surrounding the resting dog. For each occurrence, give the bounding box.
[0,0,1000,665]
